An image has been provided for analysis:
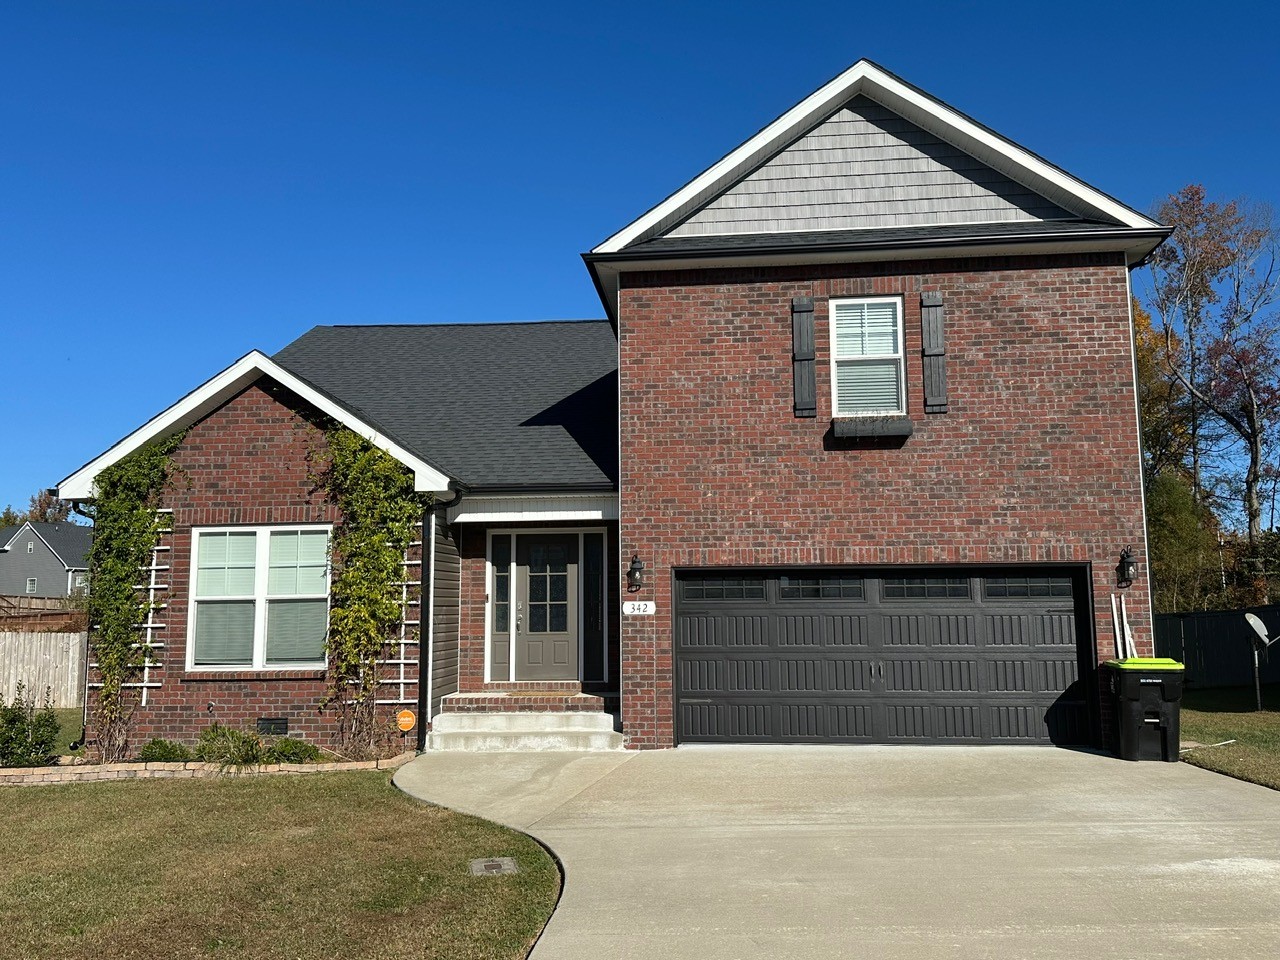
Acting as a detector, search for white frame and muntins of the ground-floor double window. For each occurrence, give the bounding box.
[187,524,333,673]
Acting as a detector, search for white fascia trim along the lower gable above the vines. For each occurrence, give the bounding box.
[58,349,449,500]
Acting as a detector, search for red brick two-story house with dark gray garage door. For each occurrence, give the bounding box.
[59,60,1169,748]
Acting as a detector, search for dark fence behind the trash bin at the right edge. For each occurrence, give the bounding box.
[1155,605,1280,686]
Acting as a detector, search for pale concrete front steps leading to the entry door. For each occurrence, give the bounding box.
[426,710,622,753]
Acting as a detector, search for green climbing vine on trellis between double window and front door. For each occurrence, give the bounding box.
[317,428,430,756]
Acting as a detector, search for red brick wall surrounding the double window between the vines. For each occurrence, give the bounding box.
[91,379,417,745]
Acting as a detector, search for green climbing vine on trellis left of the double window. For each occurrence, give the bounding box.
[86,434,183,763]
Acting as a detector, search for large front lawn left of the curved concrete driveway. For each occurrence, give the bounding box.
[0,772,559,960]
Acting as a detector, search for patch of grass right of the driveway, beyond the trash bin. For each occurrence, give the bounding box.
[1181,684,1280,790]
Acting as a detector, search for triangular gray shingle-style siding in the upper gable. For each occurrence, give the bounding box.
[664,96,1074,237]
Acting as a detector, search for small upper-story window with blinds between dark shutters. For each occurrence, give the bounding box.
[829,297,906,417]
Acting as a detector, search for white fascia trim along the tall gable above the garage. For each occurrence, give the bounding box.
[591,60,1158,253]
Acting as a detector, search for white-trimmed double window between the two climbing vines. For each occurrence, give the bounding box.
[187,526,330,669]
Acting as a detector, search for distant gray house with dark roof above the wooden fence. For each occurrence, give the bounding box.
[0,521,93,596]
